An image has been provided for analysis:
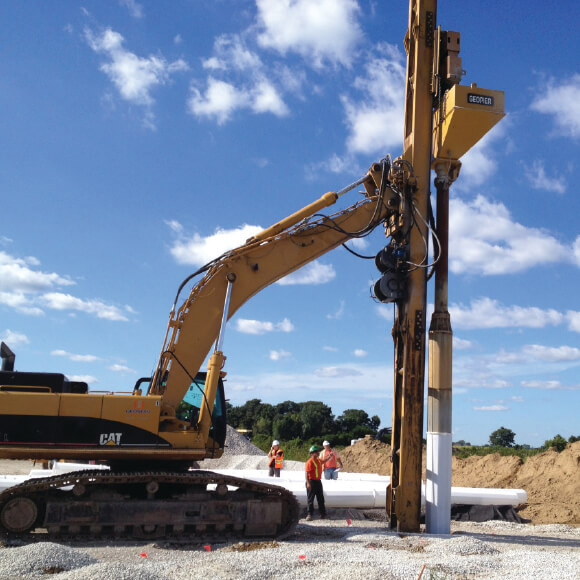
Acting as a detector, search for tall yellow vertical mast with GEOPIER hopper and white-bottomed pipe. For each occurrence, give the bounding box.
[386,0,504,532]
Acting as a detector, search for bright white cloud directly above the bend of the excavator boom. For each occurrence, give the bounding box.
[166,220,263,266]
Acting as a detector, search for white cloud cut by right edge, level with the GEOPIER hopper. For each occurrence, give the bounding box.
[530,73,580,139]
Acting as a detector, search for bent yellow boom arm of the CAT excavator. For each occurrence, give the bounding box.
[150,160,398,423]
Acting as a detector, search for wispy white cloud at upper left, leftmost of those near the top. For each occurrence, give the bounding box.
[85,28,189,129]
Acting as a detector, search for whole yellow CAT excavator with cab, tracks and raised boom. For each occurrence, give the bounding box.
[0,157,413,541]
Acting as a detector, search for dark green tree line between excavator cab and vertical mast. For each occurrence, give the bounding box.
[226,399,381,446]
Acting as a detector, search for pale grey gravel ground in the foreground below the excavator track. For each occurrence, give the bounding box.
[0,510,580,580]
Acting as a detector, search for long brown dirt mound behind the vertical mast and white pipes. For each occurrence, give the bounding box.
[340,437,580,525]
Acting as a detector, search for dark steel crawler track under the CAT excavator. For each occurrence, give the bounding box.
[0,470,299,543]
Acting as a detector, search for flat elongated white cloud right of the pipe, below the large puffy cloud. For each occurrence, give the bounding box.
[449,297,564,329]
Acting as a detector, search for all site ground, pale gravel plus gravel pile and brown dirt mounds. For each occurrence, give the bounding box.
[0,430,580,580]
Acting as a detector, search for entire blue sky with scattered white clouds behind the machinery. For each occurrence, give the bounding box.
[0,0,580,445]
